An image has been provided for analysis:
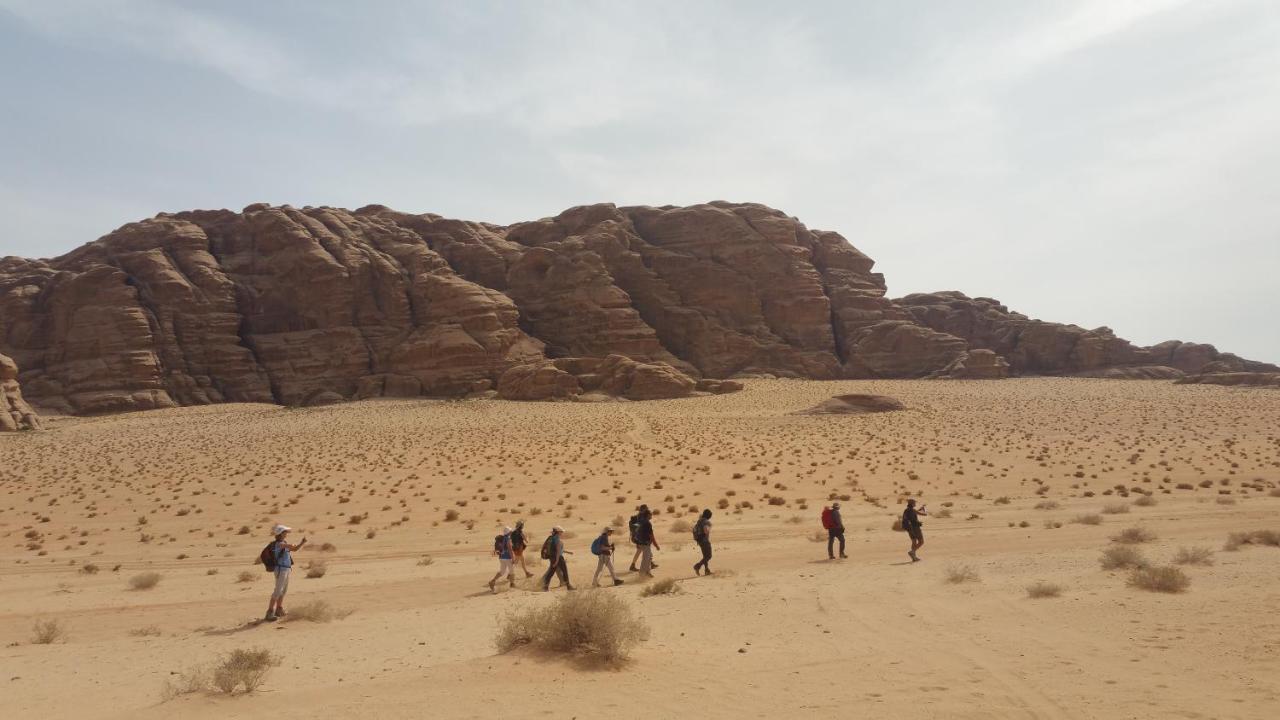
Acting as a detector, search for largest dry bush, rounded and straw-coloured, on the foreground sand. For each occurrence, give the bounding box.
[494,592,649,664]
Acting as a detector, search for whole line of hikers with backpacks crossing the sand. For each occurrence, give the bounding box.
[260,498,928,614]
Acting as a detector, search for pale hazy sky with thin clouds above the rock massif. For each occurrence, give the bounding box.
[0,0,1280,361]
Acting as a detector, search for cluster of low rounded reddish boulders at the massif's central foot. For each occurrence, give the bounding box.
[498,355,701,400]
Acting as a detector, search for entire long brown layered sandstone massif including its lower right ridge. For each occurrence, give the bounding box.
[0,202,1272,414]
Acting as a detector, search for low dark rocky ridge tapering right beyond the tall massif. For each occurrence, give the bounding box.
[895,291,1280,377]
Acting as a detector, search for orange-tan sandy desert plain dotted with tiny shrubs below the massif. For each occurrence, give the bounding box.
[0,379,1280,720]
